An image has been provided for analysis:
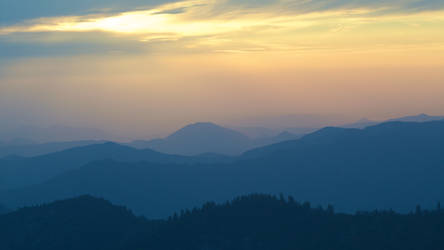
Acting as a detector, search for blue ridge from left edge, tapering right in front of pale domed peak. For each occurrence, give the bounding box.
[0,142,234,189]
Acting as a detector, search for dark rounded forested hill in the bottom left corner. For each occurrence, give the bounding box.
[0,196,153,250]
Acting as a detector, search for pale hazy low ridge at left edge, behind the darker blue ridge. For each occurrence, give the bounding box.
[0,140,105,157]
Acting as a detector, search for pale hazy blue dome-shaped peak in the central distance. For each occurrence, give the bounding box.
[128,123,300,155]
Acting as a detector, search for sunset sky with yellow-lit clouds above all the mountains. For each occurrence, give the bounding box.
[0,0,444,136]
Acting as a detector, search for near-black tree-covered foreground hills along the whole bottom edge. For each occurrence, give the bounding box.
[0,195,444,250]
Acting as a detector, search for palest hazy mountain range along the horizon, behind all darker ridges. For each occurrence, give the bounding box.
[0,114,438,157]
